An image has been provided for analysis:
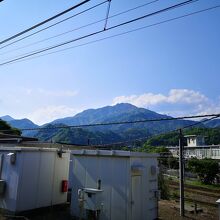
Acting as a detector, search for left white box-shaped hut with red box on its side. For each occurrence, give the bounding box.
[0,147,70,213]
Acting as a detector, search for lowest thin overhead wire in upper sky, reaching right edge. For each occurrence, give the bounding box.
[9,5,220,65]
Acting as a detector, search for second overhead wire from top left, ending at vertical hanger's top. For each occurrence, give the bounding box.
[0,0,108,49]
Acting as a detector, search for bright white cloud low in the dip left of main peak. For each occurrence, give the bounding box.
[27,105,80,125]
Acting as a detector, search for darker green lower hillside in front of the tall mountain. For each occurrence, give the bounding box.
[36,124,150,145]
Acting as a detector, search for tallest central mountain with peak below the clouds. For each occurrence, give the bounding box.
[51,103,193,134]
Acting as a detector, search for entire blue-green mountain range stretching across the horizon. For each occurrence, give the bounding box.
[0,103,220,145]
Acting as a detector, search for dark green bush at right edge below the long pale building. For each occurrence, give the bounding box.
[187,158,219,184]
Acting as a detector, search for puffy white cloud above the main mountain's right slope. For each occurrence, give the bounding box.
[112,89,220,116]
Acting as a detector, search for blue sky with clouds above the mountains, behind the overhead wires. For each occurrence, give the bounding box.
[0,0,220,124]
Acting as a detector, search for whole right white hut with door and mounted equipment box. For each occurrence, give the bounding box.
[70,150,158,220]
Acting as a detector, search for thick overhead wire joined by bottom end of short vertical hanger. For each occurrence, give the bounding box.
[0,0,198,66]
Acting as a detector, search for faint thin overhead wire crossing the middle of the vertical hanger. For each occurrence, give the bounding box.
[0,0,159,55]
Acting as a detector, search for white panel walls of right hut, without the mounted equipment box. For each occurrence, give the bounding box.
[70,151,158,220]
